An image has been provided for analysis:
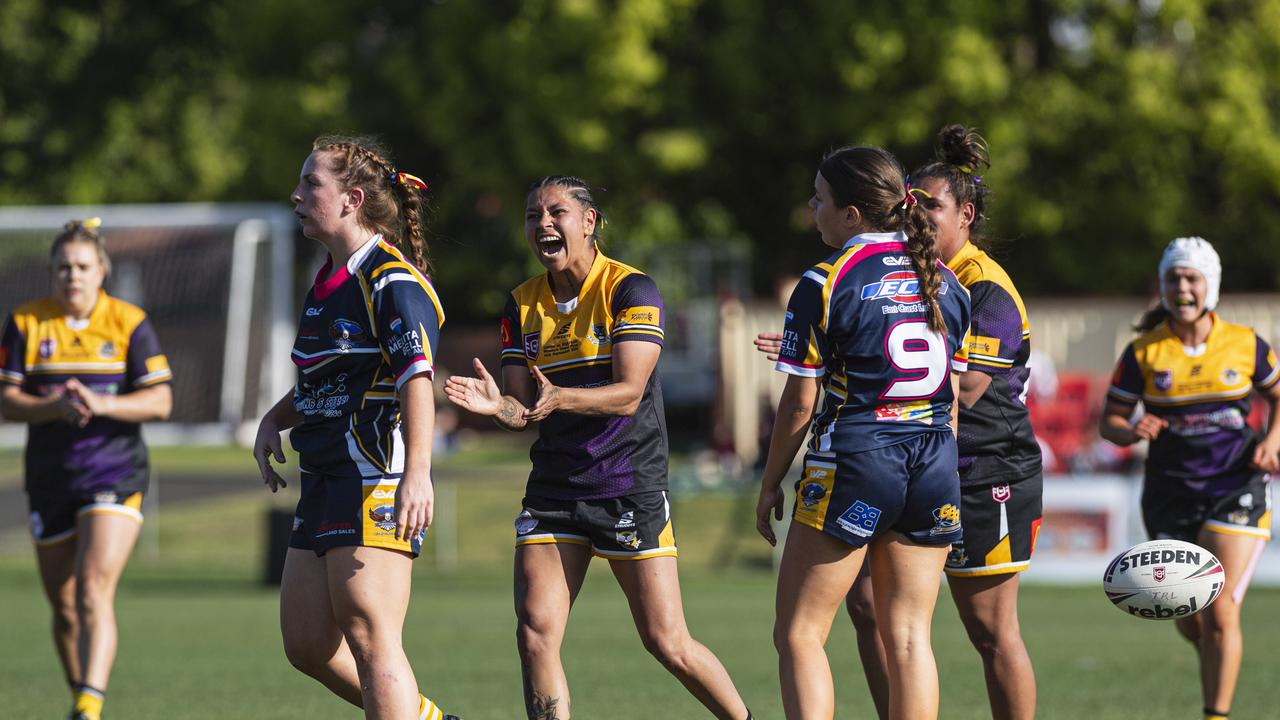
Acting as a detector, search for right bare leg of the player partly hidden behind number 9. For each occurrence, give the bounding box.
[947,573,1036,720]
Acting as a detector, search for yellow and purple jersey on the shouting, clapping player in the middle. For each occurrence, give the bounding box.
[502,251,667,500]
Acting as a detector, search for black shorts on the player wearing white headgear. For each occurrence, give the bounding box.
[1142,473,1271,542]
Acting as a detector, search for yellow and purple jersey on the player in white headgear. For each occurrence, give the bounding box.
[1107,314,1280,496]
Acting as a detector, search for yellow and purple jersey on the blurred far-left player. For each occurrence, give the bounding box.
[0,292,173,497]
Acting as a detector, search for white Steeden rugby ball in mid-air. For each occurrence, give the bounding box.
[1102,539,1226,620]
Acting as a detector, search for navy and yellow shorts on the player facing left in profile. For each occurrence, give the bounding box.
[289,473,422,557]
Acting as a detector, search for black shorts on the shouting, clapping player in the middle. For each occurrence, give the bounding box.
[516,491,677,560]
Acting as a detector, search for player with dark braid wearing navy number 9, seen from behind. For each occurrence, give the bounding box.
[756,147,969,719]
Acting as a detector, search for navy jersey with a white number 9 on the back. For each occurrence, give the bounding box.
[777,233,969,454]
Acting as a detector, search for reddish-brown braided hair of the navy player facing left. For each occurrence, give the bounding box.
[311,136,431,274]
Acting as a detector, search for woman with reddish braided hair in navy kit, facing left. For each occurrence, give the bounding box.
[253,137,453,720]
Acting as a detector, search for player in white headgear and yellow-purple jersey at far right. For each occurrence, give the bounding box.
[1100,237,1280,720]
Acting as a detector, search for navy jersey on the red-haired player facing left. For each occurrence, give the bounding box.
[291,236,444,478]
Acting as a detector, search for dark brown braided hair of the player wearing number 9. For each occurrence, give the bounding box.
[818,146,947,334]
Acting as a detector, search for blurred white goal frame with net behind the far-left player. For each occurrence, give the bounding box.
[0,204,297,446]
